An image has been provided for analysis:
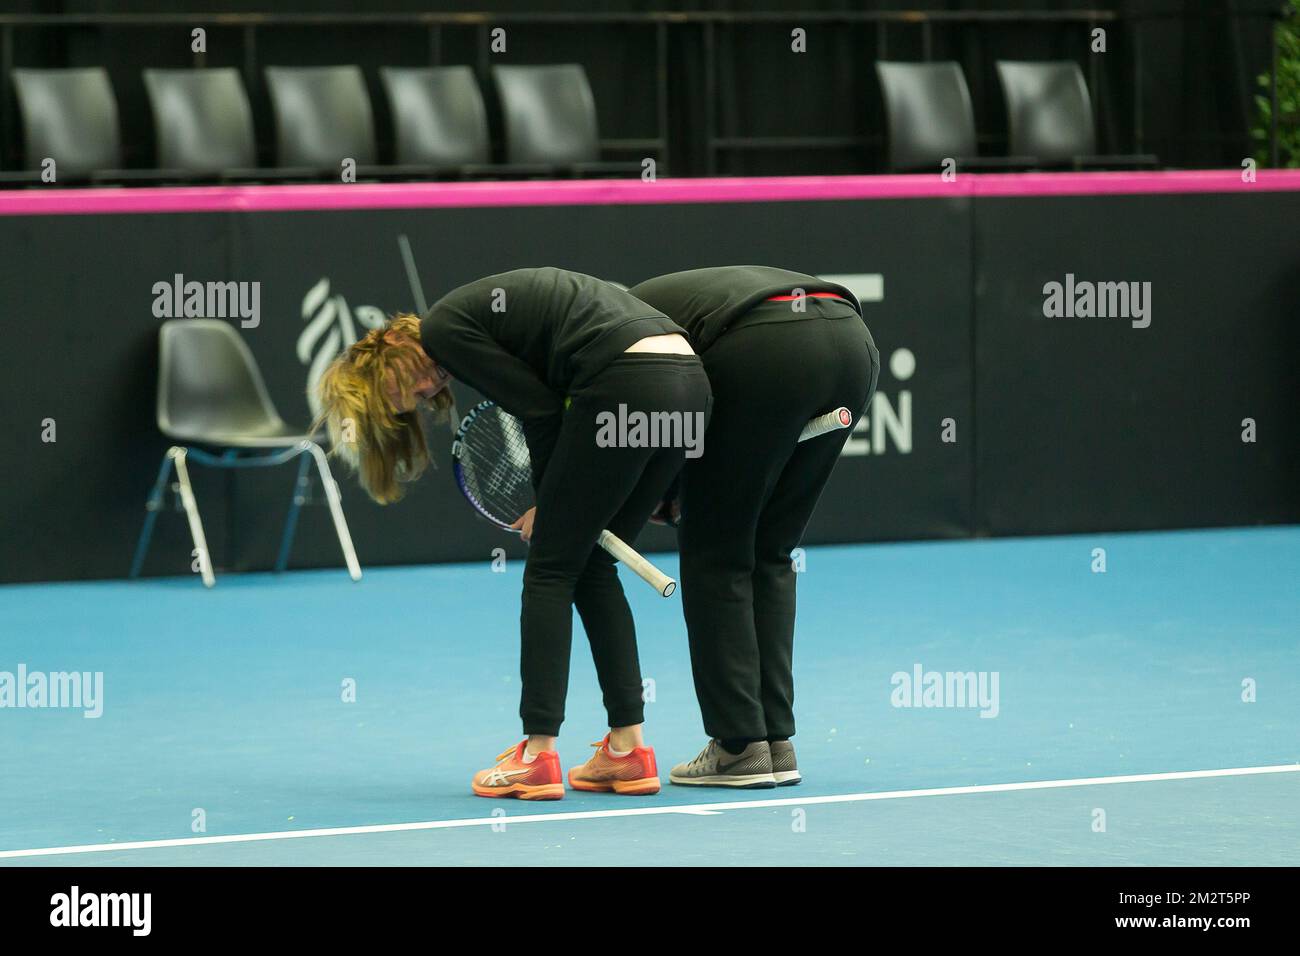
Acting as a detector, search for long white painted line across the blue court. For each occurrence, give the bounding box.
[0,763,1300,860]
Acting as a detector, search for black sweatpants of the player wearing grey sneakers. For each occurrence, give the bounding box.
[679,298,880,740]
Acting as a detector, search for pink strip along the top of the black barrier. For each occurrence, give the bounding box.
[0,169,1300,216]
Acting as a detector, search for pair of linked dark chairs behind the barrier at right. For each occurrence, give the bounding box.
[876,60,1157,172]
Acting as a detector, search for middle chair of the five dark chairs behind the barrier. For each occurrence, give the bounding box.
[267,66,377,173]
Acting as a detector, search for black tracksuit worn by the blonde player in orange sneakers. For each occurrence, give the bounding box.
[420,268,709,736]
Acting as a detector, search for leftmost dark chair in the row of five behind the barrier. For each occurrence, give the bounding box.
[13,66,122,179]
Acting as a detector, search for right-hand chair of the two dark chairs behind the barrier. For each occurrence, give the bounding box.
[997,60,1157,169]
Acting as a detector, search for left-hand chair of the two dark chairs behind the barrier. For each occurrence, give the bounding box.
[876,61,1028,172]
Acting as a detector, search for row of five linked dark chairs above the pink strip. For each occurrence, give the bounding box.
[4,64,640,183]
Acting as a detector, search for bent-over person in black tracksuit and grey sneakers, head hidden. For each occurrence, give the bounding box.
[629,265,880,786]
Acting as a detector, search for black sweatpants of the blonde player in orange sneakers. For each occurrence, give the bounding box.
[519,352,710,736]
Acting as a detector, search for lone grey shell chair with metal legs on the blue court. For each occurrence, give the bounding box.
[130,319,361,588]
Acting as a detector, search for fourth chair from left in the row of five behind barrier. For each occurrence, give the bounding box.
[380,66,491,170]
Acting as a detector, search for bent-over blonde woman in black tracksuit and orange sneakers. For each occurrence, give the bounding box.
[319,268,710,799]
